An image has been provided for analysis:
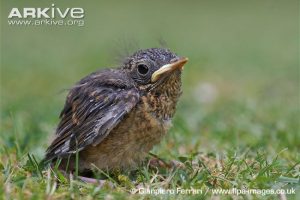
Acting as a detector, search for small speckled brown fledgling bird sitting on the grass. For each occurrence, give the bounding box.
[45,48,188,171]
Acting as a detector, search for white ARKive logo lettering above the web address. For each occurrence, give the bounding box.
[8,4,84,19]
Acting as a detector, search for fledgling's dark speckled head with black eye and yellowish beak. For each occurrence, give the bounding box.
[123,48,188,93]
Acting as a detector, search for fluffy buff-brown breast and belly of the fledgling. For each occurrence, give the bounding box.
[80,96,175,169]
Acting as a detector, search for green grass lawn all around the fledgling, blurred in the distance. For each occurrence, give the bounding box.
[0,1,300,199]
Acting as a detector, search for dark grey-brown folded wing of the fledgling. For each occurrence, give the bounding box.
[45,70,139,160]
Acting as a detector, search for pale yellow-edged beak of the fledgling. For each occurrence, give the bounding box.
[151,58,188,83]
